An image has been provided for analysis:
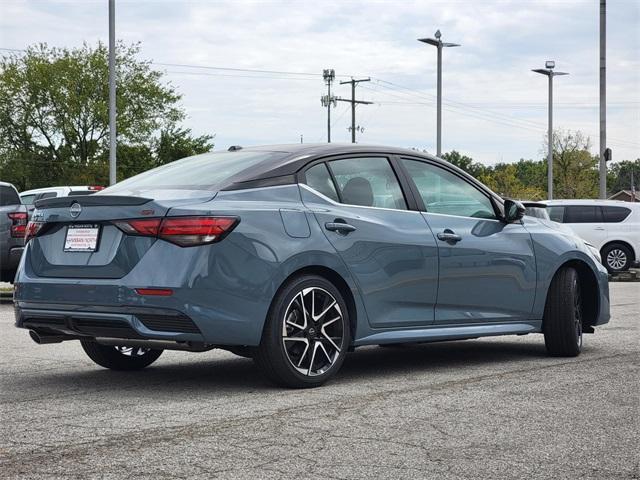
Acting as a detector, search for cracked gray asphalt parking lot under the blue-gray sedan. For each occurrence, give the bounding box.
[0,283,640,479]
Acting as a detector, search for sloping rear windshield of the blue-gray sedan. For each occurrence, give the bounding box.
[99,152,287,194]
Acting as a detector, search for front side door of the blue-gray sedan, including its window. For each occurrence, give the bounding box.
[401,158,536,324]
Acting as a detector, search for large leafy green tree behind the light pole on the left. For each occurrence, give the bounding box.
[0,43,213,189]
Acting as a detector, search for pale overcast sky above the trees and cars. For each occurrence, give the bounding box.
[0,0,640,164]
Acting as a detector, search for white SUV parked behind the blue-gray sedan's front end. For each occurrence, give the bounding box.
[543,200,640,272]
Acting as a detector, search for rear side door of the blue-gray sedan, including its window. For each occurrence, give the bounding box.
[301,155,438,327]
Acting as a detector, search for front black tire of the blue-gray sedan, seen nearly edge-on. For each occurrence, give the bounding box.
[542,267,582,357]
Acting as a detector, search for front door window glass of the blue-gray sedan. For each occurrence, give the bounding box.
[402,159,496,218]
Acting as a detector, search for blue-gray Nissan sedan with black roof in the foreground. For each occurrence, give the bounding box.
[15,144,609,387]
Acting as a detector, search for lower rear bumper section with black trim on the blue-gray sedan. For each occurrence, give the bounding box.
[15,302,205,343]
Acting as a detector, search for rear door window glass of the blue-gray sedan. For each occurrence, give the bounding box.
[329,157,407,210]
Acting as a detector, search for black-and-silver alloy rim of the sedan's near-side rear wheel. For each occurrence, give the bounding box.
[282,287,345,377]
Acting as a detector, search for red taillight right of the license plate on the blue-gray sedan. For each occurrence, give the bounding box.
[114,217,240,247]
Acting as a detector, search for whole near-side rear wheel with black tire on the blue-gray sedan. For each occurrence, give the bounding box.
[253,275,351,388]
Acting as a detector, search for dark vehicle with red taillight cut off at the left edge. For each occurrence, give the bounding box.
[0,182,27,282]
